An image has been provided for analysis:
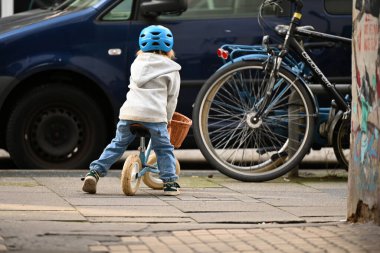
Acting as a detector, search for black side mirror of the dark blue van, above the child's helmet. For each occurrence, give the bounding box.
[140,0,187,17]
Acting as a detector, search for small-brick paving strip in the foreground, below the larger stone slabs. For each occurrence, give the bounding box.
[89,224,380,253]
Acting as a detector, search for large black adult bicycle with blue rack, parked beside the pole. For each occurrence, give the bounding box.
[193,0,351,182]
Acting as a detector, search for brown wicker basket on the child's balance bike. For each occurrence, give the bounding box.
[168,112,192,148]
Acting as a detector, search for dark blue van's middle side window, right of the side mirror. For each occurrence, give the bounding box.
[160,0,289,19]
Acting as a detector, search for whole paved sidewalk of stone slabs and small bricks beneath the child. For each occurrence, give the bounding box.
[0,170,380,253]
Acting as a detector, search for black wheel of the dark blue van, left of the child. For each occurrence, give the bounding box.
[6,83,107,169]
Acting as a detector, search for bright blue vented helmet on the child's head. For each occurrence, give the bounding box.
[139,25,174,53]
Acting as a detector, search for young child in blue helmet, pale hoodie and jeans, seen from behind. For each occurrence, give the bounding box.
[82,25,181,195]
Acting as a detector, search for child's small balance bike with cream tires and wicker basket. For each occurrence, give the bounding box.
[121,112,192,196]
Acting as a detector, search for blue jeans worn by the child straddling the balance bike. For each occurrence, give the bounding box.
[90,120,178,183]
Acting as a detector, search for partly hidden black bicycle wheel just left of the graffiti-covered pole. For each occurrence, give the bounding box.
[332,119,351,170]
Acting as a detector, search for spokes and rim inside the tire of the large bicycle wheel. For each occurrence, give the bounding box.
[203,64,310,172]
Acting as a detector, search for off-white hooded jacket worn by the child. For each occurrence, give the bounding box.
[119,53,181,123]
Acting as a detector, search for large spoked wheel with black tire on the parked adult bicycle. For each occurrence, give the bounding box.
[193,61,316,182]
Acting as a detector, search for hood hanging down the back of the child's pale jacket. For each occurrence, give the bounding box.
[131,53,181,86]
